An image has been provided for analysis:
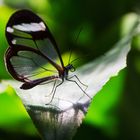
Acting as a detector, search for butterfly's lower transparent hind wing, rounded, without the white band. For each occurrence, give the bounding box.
[6,47,58,82]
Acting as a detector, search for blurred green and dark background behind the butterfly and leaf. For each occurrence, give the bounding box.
[0,0,140,140]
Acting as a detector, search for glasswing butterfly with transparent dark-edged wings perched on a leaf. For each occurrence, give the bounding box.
[5,10,88,102]
